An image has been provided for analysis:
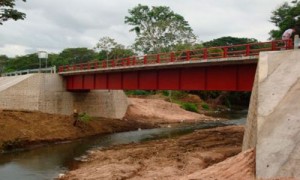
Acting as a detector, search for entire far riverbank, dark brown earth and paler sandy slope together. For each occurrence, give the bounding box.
[0,98,215,152]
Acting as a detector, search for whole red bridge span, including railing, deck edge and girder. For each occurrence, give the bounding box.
[59,40,293,91]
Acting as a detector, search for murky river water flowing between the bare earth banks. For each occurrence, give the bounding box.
[0,111,247,180]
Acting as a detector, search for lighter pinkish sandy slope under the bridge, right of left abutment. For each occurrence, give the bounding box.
[125,98,215,124]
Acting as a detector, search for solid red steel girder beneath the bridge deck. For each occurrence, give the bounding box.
[64,64,256,91]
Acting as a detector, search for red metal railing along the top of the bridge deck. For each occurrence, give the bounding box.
[59,40,293,72]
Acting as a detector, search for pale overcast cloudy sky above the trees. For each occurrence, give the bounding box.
[0,0,285,57]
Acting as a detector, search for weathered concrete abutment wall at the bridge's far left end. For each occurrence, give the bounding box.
[0,74,128,119]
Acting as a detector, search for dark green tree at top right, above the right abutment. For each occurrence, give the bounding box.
[269,0,300,39]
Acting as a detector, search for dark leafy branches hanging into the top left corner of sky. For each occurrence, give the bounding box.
[0,0,26,25]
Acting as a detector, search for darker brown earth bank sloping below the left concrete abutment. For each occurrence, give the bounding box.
[0,110,153,150]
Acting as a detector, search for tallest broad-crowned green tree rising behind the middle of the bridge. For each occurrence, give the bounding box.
[125,4,196,53]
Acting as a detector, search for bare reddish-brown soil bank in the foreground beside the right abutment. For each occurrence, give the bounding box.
[62,126,254,179]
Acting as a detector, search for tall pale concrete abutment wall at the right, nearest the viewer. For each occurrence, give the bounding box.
[243,50,300,178]
